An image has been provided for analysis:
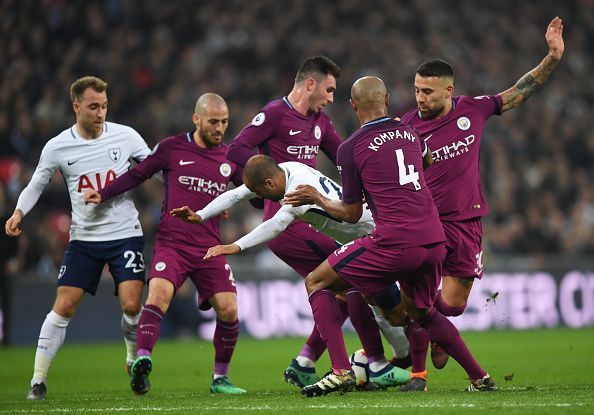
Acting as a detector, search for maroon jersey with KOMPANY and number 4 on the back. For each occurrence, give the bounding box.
[337,117,445,248]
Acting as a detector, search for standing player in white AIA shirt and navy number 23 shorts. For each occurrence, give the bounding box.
[5,76,150,400]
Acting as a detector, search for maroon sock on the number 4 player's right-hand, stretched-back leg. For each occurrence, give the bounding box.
[420,308,487,380]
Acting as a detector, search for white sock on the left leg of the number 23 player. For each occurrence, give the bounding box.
[31,310,70,386]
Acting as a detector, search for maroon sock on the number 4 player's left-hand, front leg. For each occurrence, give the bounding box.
[309,290,351,370]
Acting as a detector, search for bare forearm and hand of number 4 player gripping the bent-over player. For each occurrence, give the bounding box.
[283,184,363,223]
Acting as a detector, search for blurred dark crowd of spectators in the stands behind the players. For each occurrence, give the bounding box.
[0,0,594,280]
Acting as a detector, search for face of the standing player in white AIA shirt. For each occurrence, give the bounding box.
[72,88,107,138]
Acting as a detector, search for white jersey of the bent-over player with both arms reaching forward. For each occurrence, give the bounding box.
[196,161,375,250]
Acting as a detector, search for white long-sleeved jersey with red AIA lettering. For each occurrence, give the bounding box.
[17,122,150,241]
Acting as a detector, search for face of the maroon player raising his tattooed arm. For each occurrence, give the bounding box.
[415,74,454,119]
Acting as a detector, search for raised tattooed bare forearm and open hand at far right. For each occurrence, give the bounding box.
[499,17,565,112]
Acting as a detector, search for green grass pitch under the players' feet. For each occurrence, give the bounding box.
[0,329,594,415]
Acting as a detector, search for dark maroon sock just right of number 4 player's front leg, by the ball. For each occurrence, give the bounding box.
[347,290,385,363]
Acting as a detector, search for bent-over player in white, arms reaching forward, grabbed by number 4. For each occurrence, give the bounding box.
[171,155,409,368]
